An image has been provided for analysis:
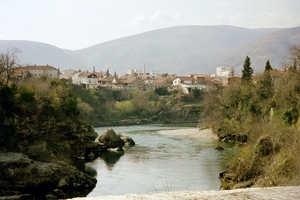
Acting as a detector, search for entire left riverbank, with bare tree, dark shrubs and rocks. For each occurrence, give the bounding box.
[0,50,98,199]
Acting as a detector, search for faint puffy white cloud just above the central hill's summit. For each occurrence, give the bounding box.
[125,11,187,28]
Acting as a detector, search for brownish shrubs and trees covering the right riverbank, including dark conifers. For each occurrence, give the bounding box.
[202,46,300,189]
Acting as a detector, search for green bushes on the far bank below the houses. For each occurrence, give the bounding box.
[71,85,203,126]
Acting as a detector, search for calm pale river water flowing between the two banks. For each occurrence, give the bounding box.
[86,125,231,197]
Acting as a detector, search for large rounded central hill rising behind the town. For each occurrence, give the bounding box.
[76,26,274,74]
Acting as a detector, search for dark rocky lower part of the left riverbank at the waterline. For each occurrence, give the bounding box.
[0,121,103,199]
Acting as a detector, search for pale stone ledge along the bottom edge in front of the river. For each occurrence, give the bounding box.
[73,186,300,200]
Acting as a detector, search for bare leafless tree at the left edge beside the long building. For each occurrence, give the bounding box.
[0,48,20,88]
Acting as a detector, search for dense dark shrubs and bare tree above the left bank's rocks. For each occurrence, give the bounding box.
[0,50,86,155]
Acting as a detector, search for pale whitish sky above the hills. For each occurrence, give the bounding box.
[0,0,300,50]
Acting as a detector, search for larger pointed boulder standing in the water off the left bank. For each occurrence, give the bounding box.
[98,129,124,149]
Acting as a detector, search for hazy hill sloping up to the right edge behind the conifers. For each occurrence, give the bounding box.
[216,26,300,72]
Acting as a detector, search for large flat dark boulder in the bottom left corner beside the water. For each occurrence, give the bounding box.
[0,153,97,197]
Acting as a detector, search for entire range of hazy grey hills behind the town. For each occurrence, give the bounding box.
[0,25,300,75]
